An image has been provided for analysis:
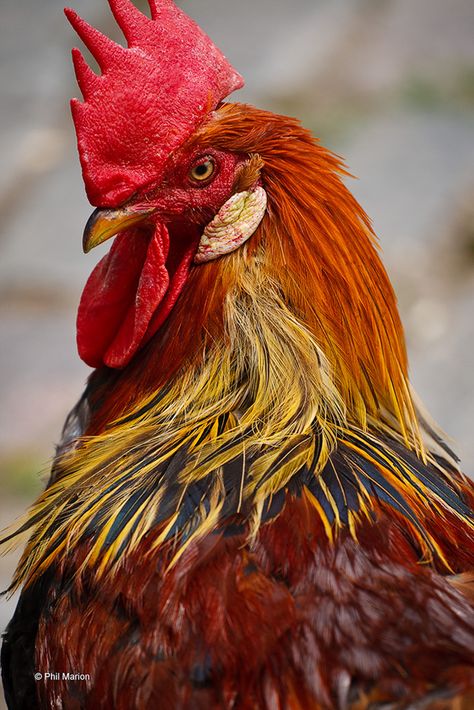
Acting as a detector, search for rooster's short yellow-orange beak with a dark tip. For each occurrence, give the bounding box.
[82,207,156,254]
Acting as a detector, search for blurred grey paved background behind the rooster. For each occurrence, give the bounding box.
[0,0,474,700]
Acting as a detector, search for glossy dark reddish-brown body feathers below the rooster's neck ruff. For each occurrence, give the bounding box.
[36,499,474,710]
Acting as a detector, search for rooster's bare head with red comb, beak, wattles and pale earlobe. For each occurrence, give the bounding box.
[65,0,266,368]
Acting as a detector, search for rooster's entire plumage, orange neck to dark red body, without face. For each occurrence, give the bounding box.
[1,105,474,708]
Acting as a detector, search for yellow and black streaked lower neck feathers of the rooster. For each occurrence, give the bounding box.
[7,268,472,584]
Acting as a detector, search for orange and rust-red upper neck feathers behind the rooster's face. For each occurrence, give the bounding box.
[88,105,424,455]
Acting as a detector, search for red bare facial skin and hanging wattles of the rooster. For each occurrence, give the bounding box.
[77,148,243,368]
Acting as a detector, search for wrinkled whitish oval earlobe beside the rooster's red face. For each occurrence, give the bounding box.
[194,187,267,264]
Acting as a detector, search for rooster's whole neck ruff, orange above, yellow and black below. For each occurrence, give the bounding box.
[5,106,470,586]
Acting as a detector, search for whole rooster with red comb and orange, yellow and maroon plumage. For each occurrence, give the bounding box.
[2,0,474,710]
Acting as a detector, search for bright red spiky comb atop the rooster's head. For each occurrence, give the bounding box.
[65,0,243,207]
